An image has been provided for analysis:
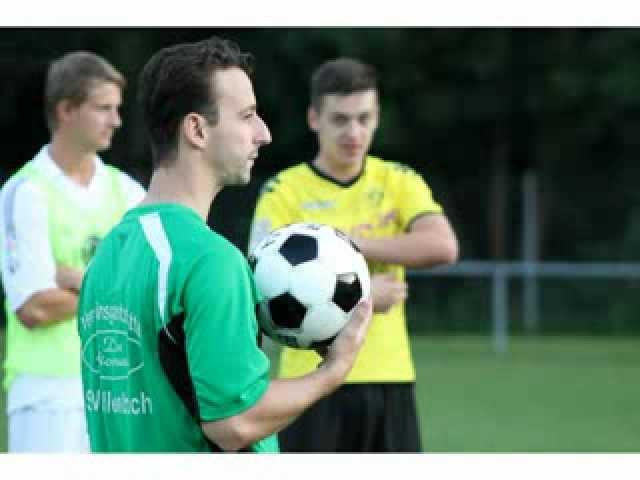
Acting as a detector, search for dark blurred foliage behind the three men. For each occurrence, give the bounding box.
[0,28,640,332]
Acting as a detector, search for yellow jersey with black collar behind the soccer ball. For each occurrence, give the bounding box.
[251,156,442,383]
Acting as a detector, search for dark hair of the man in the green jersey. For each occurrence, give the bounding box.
[138,37,252,167]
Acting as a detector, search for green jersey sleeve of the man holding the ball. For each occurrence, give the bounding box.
[184,252,269,421]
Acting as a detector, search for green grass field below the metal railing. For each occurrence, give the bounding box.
[0,331,640,452]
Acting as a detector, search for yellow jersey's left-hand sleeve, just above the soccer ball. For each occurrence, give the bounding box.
[249,176,296,251]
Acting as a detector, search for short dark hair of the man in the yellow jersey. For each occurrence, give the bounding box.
[311,58,378,112]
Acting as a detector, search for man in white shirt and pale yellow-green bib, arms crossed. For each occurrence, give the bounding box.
[0,52,144,452]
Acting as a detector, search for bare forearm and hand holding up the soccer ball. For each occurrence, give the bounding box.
[202,300,371,451]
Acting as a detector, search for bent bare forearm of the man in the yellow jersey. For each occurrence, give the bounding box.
[354,214,458,267]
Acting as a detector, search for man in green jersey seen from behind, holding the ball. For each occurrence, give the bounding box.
[78,37,371,452]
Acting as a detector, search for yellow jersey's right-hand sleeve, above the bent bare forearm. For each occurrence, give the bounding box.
[396,165,443,229]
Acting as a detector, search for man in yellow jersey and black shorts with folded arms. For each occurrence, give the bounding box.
[250,58,458,452]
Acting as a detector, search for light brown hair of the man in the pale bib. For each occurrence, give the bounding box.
[44,51,126,132]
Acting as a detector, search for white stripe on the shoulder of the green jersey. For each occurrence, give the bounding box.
[139,212,177,343]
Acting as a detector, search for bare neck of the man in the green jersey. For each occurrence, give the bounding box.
[141,154,221,222]
